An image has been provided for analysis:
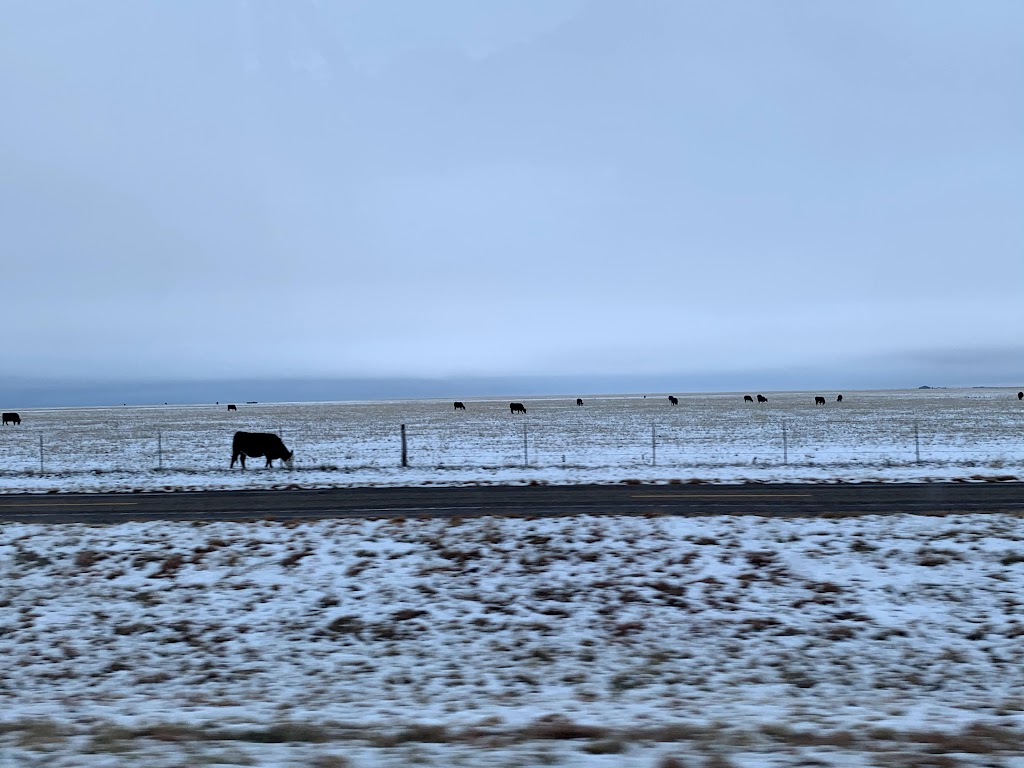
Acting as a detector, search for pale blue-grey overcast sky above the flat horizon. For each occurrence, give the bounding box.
[0,0,1024,404]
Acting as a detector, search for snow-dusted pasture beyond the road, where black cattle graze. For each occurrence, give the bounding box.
[0,389,1024,493]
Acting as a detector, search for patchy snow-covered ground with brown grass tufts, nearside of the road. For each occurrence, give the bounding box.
[0,514,1024,768]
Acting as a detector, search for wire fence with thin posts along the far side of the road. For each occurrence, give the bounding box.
[0,411,1024,475]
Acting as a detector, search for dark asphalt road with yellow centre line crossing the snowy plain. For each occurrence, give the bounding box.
[0,482,1024,524]
